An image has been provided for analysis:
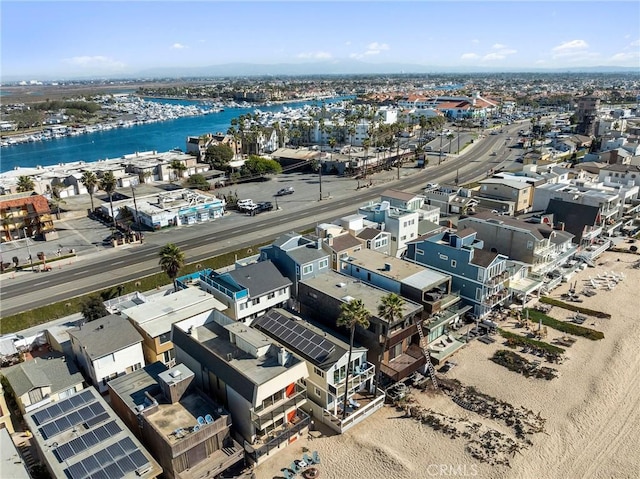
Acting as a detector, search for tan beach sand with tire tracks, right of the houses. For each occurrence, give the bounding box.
[255,252,640,479]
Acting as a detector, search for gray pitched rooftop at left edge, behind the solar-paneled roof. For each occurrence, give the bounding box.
[2,353,84,396]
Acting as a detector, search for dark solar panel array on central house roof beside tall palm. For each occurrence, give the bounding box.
[256,311,335,362]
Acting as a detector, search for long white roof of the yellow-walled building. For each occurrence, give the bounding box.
[122,288,227,338]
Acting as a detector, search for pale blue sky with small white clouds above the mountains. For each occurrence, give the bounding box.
[0,0,640,79]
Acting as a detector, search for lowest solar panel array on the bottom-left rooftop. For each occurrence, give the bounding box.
[64,437,150,479]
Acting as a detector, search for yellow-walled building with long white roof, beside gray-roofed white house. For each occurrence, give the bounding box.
[120,288,226,367]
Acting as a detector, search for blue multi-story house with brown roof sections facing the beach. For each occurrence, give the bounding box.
[405,228,510,317]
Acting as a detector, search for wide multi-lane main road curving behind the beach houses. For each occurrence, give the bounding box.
[1,125,519,317]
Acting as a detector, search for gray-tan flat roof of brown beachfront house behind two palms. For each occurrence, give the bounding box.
[301,271,422,319]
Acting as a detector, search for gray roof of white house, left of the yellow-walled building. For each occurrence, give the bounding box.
[69,314,142,360]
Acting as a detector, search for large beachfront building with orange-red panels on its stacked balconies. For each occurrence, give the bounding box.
[173,316,310,463]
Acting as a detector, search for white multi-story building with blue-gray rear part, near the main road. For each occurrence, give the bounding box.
[358,201,420,258]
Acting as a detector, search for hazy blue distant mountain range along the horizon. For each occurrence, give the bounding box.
[2,60,640,82]
